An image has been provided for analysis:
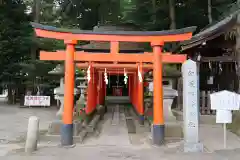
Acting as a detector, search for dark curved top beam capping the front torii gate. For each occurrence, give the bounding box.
[31,22,196,36]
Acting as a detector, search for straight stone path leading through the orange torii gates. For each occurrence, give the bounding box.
[84,105,130,146]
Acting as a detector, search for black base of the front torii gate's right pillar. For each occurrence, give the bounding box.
[152,125,165,145]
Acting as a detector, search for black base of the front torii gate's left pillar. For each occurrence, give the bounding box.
[61,124,73,147]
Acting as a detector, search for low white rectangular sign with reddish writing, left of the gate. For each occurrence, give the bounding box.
[24,96,50,106]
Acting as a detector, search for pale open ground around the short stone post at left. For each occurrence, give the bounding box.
[0,102,57,144]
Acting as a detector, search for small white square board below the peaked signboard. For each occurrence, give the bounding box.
[216,110,232,123]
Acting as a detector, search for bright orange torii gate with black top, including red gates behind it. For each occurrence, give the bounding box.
[32,23,196,146]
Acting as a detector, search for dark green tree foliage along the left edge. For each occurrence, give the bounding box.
[0,0,32,82]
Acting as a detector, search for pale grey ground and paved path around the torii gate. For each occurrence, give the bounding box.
[0,101,240,160]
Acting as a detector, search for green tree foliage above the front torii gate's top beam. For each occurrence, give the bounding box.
[54,0,236,30]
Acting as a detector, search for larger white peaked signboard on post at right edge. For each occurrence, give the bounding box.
[210,90,240,110]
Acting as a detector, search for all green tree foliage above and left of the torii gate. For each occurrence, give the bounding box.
[0,0,236,99]
